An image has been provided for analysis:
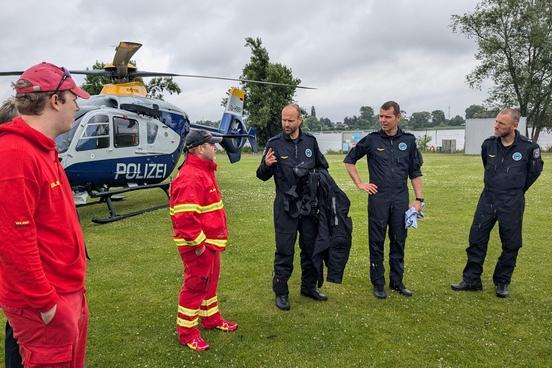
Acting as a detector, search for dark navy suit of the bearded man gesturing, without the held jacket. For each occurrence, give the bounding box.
[257,132,328,295]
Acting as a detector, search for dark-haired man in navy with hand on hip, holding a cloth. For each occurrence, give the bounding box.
[343,101,424,299]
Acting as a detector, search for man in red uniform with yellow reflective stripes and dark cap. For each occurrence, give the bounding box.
[170,130,238,351]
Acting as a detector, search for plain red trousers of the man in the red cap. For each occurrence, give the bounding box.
[2,291,88,368]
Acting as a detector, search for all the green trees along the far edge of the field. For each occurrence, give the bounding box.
[83,0,552,145]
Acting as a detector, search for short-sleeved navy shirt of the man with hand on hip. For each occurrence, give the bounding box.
[343,128,423,192]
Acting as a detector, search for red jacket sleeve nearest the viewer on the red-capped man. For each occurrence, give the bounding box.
[0,152,58,312]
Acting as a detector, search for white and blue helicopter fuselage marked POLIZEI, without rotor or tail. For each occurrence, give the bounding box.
[56,95,190,190]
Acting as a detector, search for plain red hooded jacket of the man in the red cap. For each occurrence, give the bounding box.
[0,118,86,312]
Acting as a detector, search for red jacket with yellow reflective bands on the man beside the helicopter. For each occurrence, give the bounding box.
[170,153,228,252]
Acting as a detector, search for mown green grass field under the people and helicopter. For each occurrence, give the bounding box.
[0,153,552,367]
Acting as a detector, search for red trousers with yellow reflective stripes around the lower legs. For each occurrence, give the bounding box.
[176,248,222,344]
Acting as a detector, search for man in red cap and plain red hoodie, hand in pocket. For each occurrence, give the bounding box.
[0,63,90,367]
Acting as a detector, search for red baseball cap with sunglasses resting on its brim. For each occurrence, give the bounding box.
[15,62,90,98]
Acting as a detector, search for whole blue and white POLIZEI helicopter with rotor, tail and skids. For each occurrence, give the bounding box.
[0,42,311,223]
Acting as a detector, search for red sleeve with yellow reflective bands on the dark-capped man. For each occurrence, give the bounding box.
[170,180,206,253]
